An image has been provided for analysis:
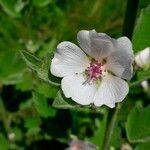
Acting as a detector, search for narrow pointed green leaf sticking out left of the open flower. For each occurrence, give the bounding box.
[21,51,60,86]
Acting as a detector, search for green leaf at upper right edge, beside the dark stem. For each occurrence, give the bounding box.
[132,6,150,52]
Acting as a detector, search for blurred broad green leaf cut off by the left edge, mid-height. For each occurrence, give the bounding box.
[0,51,25,85]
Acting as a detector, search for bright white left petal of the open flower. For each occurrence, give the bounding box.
[51,41,89,77]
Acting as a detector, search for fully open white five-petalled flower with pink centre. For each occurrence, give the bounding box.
[51,30,133,108]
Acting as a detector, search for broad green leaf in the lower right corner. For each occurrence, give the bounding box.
[126,106,150,143]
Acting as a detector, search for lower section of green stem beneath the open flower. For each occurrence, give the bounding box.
[103,103,121,150]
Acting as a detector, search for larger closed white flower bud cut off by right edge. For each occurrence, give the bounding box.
[135,47,150,68]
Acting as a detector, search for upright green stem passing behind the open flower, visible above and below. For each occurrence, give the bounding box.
[102,0,139,150]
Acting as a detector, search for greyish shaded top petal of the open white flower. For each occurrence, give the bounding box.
[77,30,115,60]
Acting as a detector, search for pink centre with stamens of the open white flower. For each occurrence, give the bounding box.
[84,60,107,84]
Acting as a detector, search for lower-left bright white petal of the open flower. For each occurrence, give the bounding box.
[61,74,96,105]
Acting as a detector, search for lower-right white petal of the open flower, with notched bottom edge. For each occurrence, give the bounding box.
[94,75,129,108]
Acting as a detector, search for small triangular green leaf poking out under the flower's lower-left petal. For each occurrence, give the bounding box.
[52,91,79,109]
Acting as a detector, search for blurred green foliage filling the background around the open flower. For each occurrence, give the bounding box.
[0,0,150,150]
